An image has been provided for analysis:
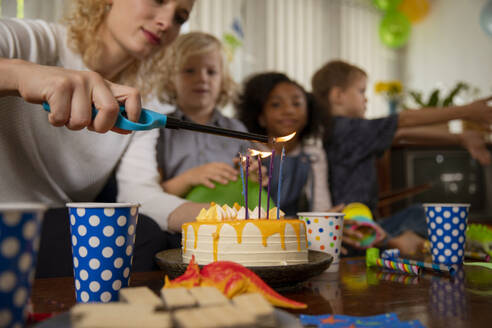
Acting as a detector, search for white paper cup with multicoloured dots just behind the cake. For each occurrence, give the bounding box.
[297,212,345,271]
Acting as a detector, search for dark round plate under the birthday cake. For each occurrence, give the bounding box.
[155,248,333,289]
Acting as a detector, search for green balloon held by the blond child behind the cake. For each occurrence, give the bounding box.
[185,179,275,210]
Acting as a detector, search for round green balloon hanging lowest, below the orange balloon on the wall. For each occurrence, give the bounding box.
[379,11,412,48]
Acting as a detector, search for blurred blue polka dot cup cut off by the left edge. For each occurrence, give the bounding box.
[0,203,46,327]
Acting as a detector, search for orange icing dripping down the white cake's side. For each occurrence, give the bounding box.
[183,219,307,261]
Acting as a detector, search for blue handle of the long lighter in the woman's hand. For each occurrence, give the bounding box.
[43,102,167,131]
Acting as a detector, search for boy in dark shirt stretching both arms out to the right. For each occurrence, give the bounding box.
[312,61,492,253]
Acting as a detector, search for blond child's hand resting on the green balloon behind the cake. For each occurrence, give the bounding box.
[162,162,238,197]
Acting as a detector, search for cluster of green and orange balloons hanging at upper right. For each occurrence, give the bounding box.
[372,0,429,48]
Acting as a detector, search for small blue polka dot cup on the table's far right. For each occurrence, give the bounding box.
[423,204,470,265]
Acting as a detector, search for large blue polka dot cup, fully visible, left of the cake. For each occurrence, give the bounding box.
[67,203,139,303]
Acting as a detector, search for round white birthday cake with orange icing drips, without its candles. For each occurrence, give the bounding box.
[182,204,308,266]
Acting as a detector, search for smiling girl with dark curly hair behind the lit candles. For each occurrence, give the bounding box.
[236,72,331,217]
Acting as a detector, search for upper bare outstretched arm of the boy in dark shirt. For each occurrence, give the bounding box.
[398,97,492,128]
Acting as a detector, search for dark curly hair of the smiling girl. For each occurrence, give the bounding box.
[236,72,325,140]
